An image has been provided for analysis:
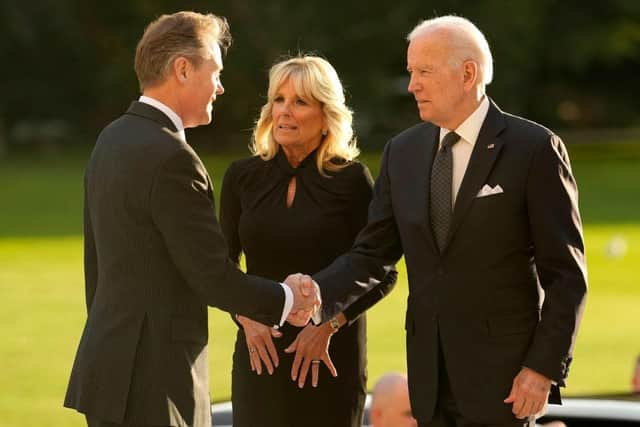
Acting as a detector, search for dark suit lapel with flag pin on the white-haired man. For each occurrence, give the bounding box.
[448,101,505,246]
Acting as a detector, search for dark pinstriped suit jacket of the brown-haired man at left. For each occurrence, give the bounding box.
[64,102,284,427]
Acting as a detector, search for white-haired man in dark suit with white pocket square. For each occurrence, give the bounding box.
[314,16,587,426]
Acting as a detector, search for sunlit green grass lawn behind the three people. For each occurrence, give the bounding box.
[0,144,640,426]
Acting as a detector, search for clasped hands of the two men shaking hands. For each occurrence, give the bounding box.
[284,273,322,326]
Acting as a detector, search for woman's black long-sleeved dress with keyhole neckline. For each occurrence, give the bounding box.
[220,150,396,427]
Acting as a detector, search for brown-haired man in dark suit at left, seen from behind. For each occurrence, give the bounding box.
[64,12,320,427]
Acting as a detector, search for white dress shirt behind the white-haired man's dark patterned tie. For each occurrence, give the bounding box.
[439,95,489,206]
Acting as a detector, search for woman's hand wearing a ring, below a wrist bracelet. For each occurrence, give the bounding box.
[284,323,338,388]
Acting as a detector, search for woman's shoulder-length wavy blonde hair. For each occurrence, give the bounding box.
[250,55,360,175]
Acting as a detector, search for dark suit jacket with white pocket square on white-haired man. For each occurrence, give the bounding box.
[314,102,587,424]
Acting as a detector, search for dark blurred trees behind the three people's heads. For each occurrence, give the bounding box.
[0,0,640,153]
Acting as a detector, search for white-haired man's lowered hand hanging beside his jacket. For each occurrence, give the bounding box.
[504,367,551,418]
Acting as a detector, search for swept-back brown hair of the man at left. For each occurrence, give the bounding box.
[134,12,231,92]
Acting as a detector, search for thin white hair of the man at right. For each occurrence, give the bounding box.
[407,15,493,86]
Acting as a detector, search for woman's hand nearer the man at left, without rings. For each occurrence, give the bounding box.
[236,315,282,375]
